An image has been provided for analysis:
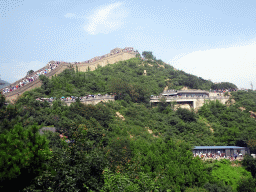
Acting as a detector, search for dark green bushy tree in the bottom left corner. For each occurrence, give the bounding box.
[0,123,51,191]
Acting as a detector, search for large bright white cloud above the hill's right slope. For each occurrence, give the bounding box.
[169,42,256,88]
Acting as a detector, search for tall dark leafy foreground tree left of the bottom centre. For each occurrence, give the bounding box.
[22,121,106,191]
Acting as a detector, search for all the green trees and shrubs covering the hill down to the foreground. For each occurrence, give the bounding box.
[0,54,256,192]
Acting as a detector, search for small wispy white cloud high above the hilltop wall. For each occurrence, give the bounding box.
[84,2,127,35]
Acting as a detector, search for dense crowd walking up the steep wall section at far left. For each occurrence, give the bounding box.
[3,61,60,94]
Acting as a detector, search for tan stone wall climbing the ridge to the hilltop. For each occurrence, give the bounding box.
[2,47,137,103]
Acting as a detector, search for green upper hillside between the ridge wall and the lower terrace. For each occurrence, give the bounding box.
[17,58,237,102]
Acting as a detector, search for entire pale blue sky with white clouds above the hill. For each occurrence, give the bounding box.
[0,0,256,89]
